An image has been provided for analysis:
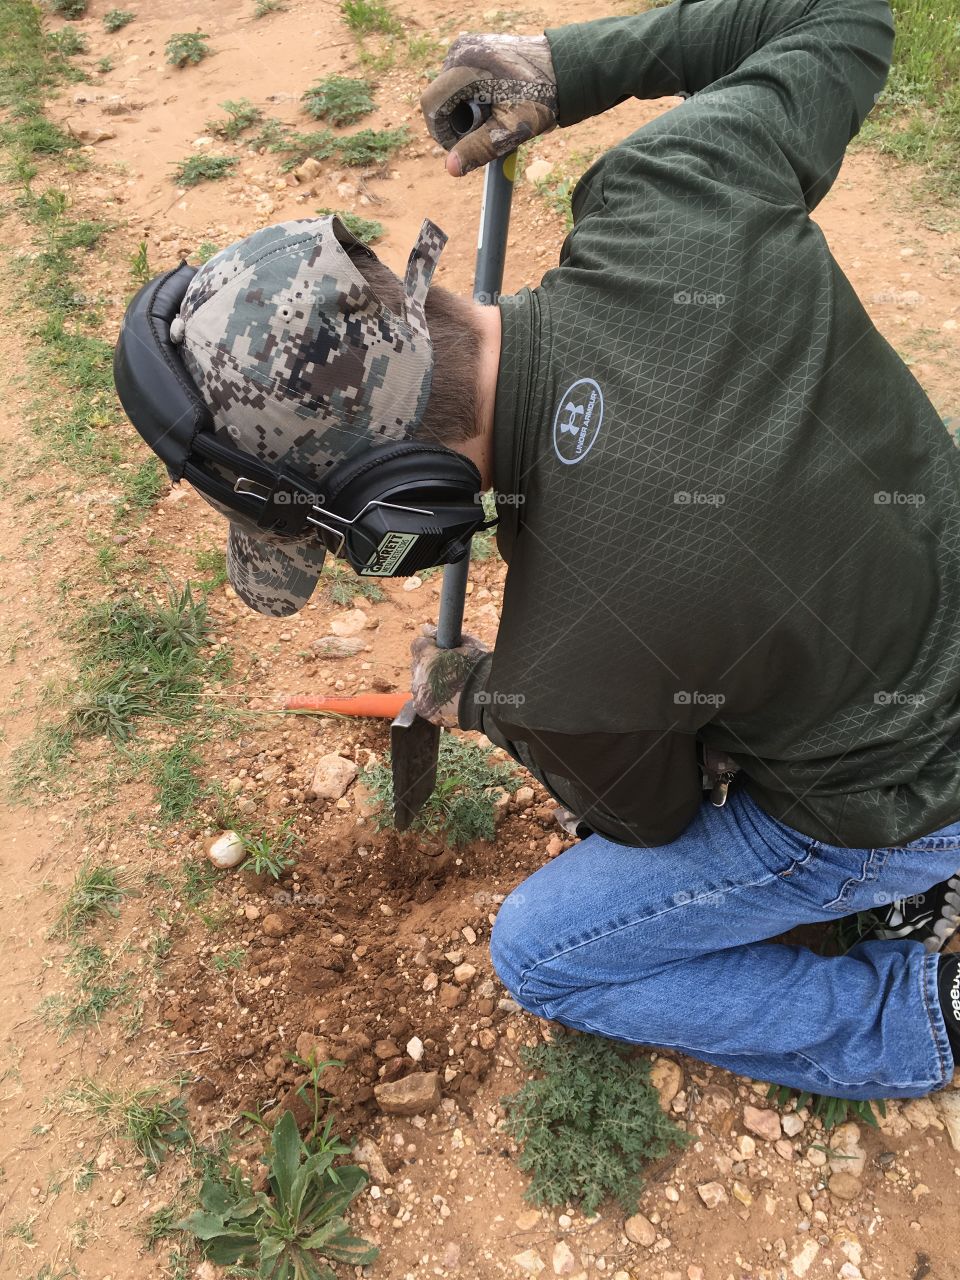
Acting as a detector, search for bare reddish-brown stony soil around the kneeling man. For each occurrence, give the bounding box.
[0,0,960,1280]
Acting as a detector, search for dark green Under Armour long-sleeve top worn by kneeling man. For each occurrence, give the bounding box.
[461,0,960,846]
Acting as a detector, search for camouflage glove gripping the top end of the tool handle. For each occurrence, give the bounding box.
[420,36,558,177]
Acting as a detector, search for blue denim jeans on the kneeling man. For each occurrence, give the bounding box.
[490,791,960,1098]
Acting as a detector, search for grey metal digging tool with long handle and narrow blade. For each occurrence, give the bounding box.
[390,117,517,831]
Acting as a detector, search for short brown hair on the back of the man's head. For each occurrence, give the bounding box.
[347,246,481,445]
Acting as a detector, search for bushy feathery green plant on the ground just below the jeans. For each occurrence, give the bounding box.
[502,1030,689,1216]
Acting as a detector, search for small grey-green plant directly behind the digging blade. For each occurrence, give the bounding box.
[362,733,516,849]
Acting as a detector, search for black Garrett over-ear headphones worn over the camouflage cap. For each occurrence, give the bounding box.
[114,262,493,577]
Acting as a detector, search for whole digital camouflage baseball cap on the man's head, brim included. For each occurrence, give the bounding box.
[170,216,447,617]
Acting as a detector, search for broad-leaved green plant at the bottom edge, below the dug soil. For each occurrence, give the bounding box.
[177,1111,379,1280]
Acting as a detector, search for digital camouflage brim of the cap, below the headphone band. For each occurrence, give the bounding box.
[227,525,325,618]
